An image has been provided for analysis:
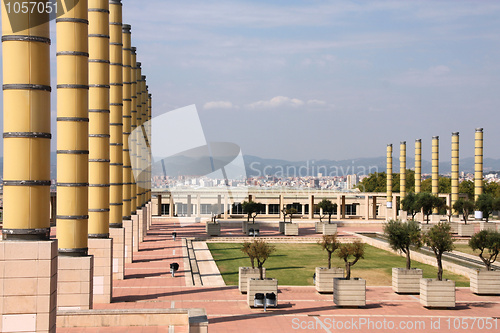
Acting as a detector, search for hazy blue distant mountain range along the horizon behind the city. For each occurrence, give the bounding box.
[0,152,500,179]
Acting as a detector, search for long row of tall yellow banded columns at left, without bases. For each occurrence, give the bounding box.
[2,0,151,252]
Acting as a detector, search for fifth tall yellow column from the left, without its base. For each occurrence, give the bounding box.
[122,24,132,220]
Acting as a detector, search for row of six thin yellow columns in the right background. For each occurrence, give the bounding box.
[387,128,483,218]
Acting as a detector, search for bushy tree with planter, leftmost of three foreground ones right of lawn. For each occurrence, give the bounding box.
[384,220,422,293]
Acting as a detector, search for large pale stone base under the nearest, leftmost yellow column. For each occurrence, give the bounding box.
[0,240,57,333]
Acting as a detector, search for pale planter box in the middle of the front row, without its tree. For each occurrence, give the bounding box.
[333,278,366,306]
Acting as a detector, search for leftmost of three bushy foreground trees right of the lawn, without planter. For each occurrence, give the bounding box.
[384,220,422,269]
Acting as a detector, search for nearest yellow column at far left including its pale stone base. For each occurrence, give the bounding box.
[0,1,57,326]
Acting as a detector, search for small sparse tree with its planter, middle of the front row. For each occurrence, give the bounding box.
[333,240,366,306]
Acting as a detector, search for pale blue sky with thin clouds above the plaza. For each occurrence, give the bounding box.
[0,0,500,161]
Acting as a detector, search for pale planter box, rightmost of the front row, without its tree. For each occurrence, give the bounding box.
[420,279,456,308]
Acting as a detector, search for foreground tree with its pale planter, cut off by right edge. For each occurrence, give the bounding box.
[469,230,500,295]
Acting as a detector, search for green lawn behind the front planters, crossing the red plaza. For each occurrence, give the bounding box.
[207,243,469,287]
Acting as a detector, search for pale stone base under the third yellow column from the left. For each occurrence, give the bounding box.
[88,238,113,304]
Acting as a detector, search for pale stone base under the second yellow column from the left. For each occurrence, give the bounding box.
[57,256,94,310]
